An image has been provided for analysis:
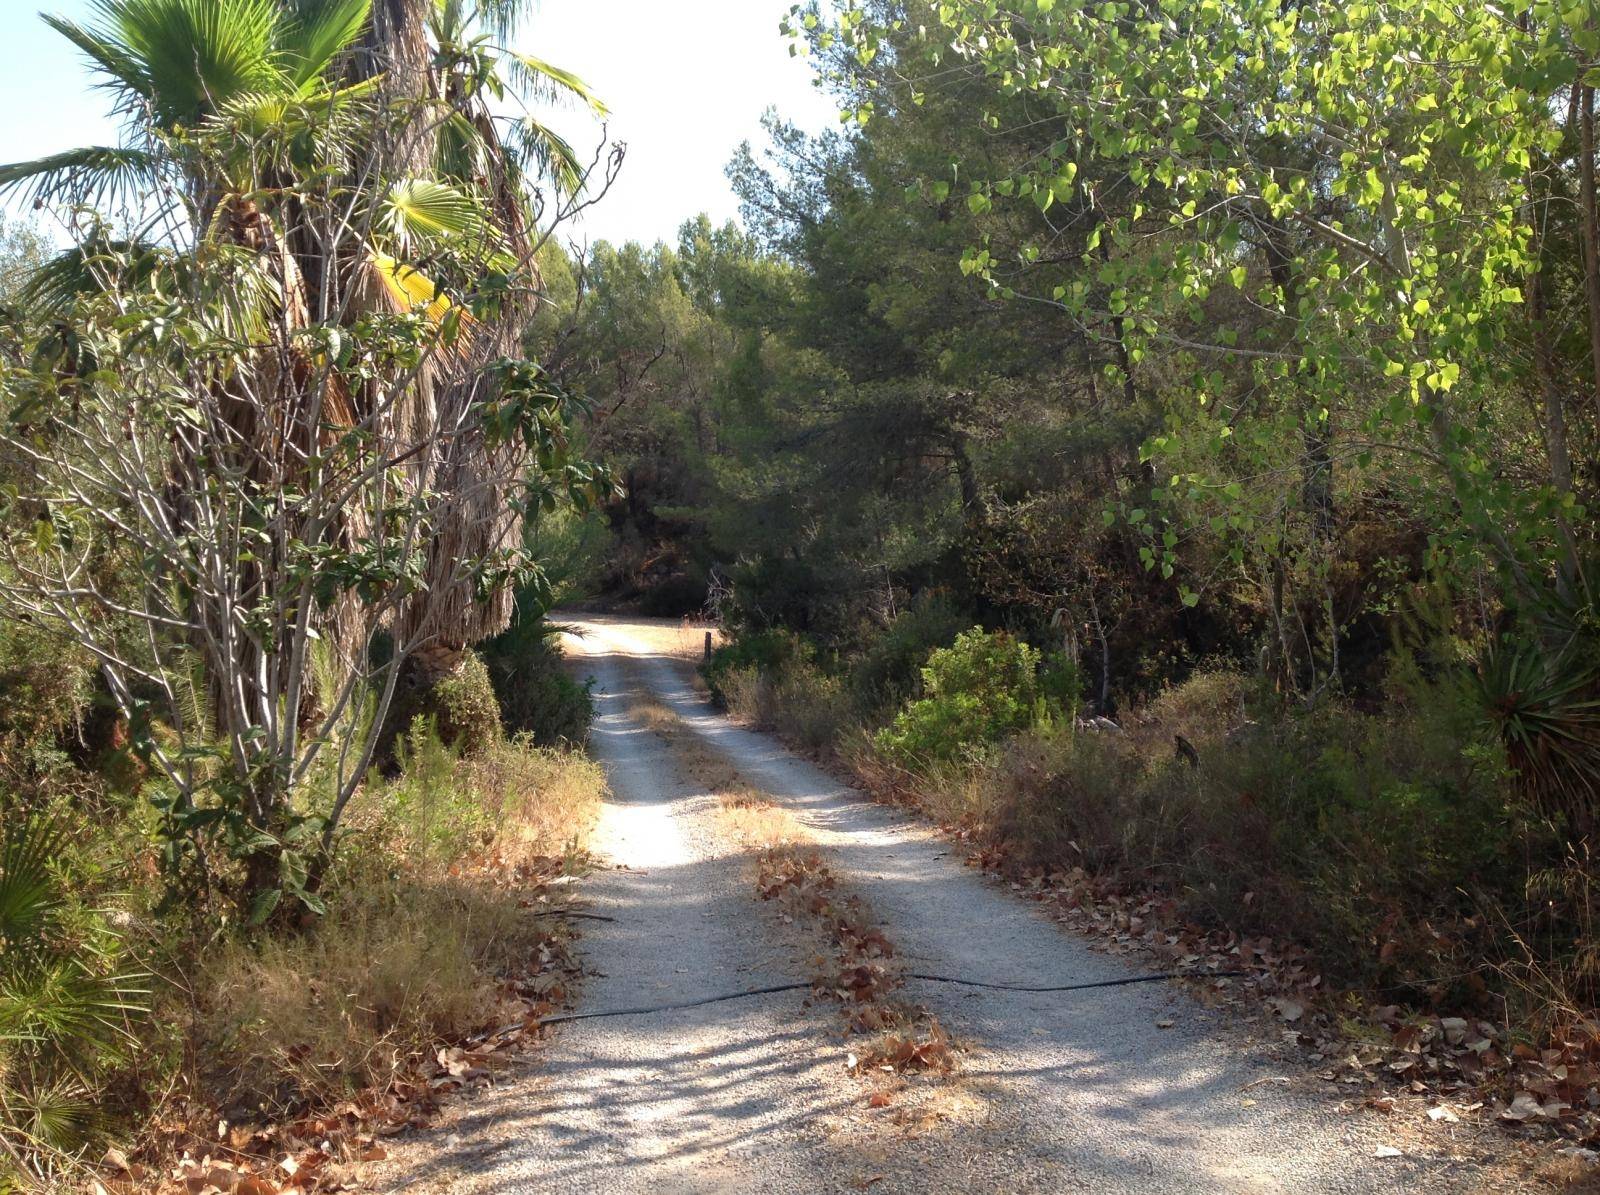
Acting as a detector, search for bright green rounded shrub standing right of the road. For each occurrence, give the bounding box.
[874,627,1077,768]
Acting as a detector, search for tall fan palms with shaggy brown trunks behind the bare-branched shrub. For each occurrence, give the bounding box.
[0,0,603,889]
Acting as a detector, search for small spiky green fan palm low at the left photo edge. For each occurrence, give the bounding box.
[0,817,149,1176]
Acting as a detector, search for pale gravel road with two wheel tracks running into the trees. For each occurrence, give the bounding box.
[371,616,1506,1193]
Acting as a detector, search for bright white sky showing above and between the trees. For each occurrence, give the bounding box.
[0,0,837,242]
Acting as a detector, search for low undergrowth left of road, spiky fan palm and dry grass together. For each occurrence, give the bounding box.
[0,718,605,1190]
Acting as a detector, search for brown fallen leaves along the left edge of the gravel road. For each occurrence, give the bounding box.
[90,857,581,1195]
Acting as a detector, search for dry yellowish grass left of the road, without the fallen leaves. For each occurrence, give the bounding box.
[195,742,605,1109]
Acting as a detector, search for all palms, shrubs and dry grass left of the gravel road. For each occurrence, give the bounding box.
[0,0,621,1192]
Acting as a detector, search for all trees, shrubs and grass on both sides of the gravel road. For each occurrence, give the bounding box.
[9,0,1600,1190]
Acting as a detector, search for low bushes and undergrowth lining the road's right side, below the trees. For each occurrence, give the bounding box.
[718,617,1587,1021]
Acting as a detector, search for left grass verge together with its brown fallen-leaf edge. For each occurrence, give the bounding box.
[79,728,605,1195]
